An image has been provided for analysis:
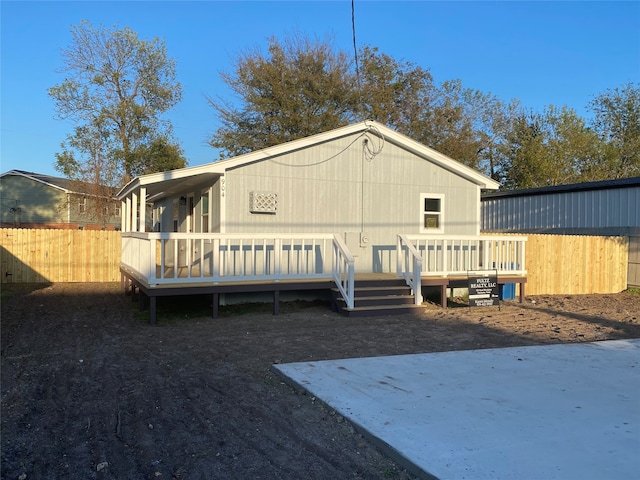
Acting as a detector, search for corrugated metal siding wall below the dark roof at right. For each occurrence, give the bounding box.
[482,187,640,231]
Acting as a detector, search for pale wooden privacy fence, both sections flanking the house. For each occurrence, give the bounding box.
[0,228,629,295]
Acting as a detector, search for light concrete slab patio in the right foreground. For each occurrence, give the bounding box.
[274,339,640,480]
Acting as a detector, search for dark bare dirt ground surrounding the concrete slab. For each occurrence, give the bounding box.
[1,283,640,480]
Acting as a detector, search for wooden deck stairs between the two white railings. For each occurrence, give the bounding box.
[331,273,424,317]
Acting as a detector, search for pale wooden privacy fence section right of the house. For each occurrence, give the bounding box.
[526,234,629,295]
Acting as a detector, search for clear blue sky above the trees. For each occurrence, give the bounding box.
[0,0,640,176]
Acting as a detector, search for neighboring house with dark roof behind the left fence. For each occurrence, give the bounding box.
[0,170,121,230]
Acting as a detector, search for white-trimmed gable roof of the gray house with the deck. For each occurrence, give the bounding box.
[118,121,500,199]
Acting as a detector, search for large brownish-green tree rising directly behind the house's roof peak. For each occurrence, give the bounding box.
[208,35,524,174]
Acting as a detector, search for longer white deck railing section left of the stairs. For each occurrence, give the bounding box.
[122,232,355,308]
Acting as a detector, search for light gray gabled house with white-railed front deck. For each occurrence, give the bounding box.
[118,122,525,320]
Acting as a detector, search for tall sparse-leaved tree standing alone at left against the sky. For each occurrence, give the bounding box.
[49,21,186,186]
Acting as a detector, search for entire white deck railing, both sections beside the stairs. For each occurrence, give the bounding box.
[122,232,527,308]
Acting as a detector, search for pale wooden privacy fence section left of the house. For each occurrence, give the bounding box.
[0,228,122,283]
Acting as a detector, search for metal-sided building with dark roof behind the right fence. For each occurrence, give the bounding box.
[482,177,640,286]
